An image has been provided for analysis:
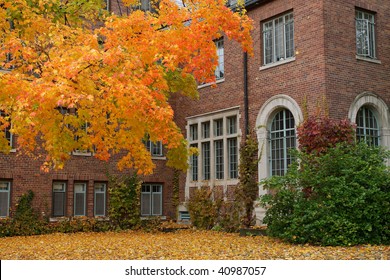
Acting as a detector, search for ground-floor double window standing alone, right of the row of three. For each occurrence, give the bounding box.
[141,184,162,216]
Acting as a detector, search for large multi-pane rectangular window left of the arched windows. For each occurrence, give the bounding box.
[188,111,238,181]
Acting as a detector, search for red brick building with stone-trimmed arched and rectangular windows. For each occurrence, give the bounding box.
[0,0,390,223]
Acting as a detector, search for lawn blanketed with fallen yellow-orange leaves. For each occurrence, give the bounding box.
[0,230,390,260]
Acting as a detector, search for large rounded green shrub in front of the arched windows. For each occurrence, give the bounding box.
[261,143,390,246]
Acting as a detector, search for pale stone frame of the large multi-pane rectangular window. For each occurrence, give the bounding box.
[187,107,241,186]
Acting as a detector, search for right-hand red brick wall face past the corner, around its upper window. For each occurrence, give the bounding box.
[324,0,390,118]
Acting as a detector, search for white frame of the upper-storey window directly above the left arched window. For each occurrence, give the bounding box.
[263,12,295,65]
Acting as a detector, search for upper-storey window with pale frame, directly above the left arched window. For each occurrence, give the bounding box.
[263,13,294,65]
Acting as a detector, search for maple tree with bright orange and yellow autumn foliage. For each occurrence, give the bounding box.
[0,0,252,174]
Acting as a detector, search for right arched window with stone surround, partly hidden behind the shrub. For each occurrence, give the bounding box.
[356,106,380,146]
